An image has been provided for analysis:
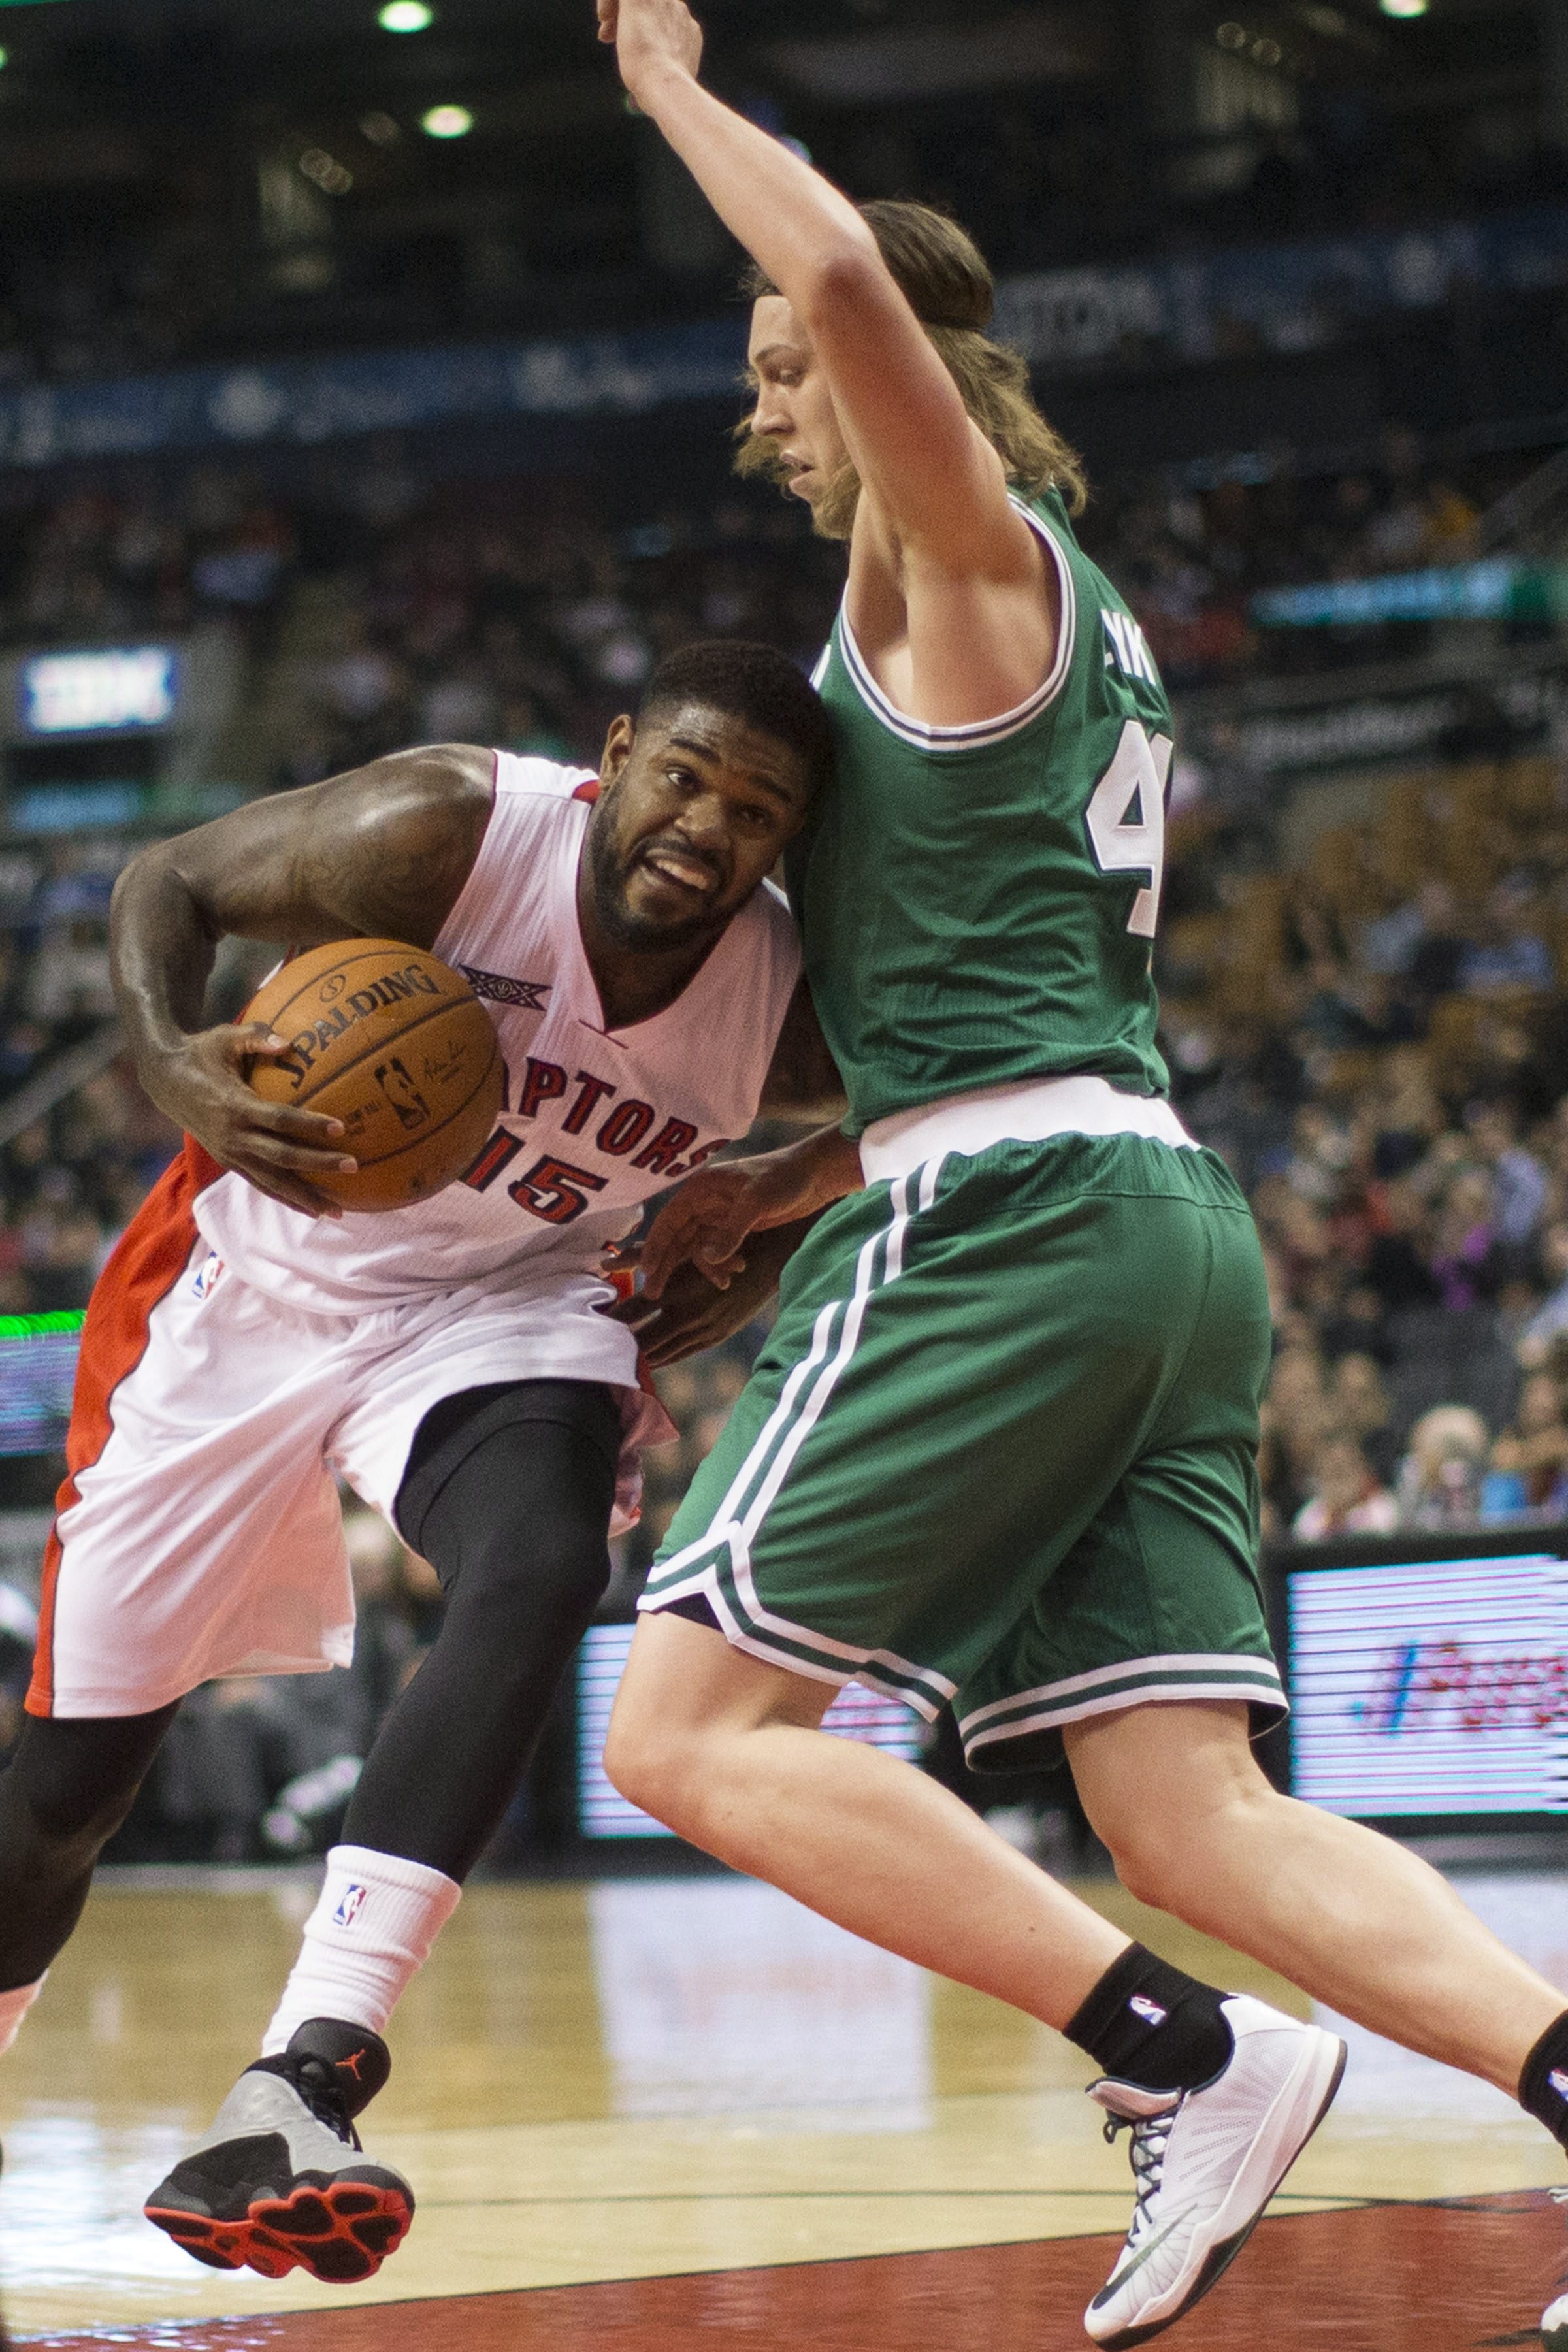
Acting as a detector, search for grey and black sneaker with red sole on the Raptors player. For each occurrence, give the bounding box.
[143,2018,414,2286]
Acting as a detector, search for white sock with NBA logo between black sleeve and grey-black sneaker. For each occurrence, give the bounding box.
[261,1846,463,2058]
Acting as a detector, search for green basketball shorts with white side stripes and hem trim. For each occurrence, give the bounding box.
[642,1134,1286,1769]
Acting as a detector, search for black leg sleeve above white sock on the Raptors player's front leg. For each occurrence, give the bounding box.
[343,1380,621,1879]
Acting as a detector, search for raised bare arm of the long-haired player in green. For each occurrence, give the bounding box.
[597,0,1039,583]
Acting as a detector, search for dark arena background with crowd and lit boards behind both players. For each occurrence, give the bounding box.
[0,0,1568,2343]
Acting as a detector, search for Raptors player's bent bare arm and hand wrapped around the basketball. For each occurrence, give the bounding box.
[110,745,494,1216]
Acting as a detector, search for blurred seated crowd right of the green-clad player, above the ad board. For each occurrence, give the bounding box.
[1162,753,1568,1538]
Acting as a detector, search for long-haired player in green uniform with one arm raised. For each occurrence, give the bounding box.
[600,0,1568,2345]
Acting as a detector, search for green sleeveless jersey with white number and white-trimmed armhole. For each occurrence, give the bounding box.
[790,491,1171,1134]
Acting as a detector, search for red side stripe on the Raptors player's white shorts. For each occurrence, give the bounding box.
[26,1136,223,1714]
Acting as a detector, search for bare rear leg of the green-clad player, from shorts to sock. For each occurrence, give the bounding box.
[1065,1703,1563,2093]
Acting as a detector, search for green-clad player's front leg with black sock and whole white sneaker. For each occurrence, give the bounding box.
[604,1616,1345,2347]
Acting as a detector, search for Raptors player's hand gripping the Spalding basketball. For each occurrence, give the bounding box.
[139,1021,357,1216]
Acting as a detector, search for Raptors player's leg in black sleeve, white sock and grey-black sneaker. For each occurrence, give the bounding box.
[146,1380,621,2281]
